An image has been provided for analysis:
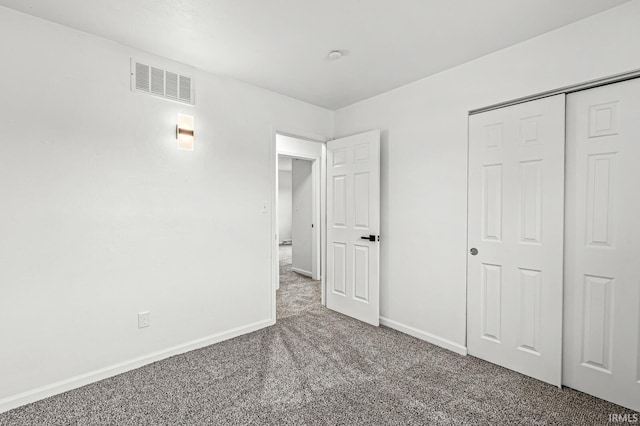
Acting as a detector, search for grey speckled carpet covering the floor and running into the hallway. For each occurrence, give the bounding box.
[0,247,632,425]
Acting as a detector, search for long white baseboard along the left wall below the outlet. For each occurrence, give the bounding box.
[0,319,273,413]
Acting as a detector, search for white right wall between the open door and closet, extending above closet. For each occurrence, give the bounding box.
[335,0,640,352]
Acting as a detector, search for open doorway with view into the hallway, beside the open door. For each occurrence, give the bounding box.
[272,134,325,322]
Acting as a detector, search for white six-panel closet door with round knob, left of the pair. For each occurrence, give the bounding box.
[467,95,565,386]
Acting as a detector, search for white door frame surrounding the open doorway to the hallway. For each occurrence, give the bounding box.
[270,126,330,325]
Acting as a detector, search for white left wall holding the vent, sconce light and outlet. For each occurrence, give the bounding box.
[0,7,333,411]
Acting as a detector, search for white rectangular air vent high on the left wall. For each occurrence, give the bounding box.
[131,59,194,105]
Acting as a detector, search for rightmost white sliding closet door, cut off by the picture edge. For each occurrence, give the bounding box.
[563,79,640,410]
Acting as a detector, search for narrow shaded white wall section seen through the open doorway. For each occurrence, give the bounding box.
[291,158,313,275]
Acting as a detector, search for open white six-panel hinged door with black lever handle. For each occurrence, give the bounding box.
[326,130,380,326]
